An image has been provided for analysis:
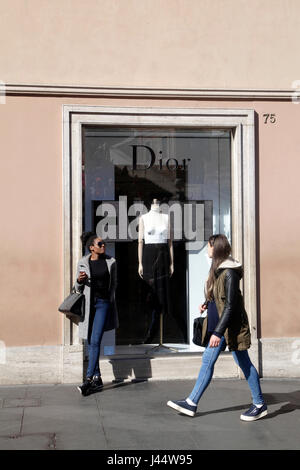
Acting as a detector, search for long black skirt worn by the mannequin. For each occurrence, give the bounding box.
[143,243,171,313]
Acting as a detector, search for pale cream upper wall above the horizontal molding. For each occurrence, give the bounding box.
[0,0,300,89]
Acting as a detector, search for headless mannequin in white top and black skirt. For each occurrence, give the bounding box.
[138,199,174,347]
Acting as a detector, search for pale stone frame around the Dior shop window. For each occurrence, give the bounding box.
[62,105,258,363]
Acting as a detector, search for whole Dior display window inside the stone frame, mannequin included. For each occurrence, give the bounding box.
[82,126,231,352]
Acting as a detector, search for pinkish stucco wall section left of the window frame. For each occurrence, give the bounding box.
[0,97,62,346]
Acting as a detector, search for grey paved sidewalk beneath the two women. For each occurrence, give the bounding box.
[0,379,300,450]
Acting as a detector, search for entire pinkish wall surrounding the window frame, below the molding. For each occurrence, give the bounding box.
[0,96,300,346]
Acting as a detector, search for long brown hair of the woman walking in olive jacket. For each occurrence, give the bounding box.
[206,234,231,300]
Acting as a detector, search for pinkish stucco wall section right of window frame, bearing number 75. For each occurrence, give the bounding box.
[254,103,300,337]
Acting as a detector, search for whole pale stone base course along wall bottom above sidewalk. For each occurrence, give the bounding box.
[0,338,300,385]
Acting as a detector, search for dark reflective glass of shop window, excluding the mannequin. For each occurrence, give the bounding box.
[83,126,231,345]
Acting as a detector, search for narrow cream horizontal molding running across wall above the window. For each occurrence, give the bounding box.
[0,82,297,100]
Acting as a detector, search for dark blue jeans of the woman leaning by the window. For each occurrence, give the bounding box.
[86,298,110,377]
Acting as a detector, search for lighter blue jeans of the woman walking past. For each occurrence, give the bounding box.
[188,336,264,405]
